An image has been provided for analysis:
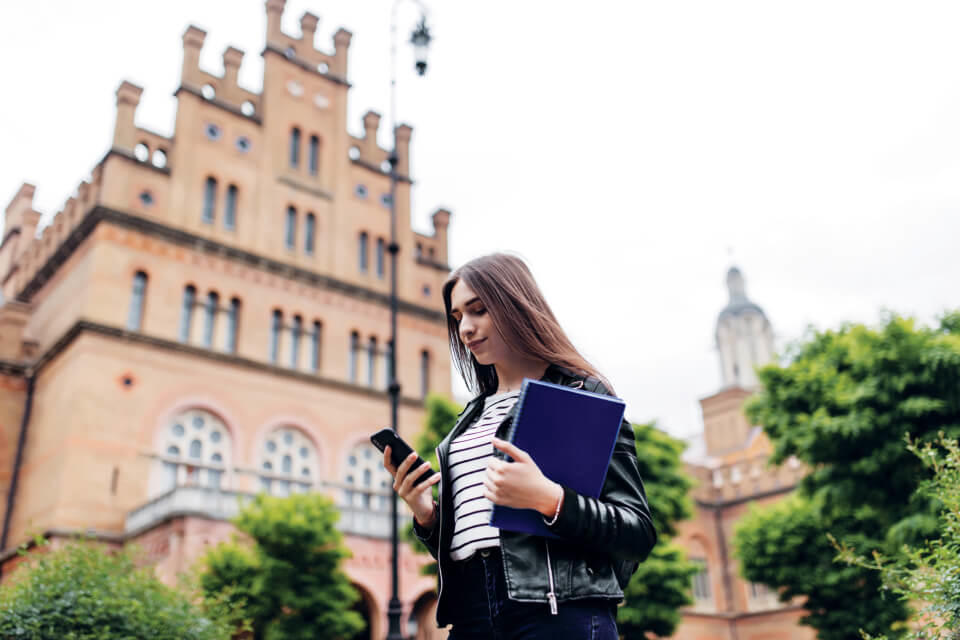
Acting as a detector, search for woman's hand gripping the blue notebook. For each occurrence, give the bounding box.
[483,438,563,518]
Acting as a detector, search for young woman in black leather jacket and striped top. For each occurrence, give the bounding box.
[384,254,657,640]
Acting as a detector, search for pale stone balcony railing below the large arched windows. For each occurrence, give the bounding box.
[124,485,412,538]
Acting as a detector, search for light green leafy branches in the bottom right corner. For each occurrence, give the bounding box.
[833,435,960,640]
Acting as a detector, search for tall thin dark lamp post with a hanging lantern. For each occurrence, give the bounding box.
[387,5,430,640]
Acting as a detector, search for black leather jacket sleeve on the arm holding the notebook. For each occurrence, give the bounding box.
[549,379,657,561]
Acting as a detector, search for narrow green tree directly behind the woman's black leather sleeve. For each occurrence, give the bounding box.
[617,423,698,640]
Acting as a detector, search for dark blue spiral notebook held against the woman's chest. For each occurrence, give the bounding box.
[490,378,625,538]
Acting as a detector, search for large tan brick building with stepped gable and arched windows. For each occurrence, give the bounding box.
[0,0,450,638]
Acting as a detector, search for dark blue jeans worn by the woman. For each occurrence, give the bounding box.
[448,549,619,640]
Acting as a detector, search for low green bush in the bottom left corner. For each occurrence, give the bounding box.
[0,542,235,640]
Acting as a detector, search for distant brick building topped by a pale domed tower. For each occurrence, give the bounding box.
[674,268,815,640]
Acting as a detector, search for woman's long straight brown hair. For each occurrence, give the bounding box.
[443,253,613,395]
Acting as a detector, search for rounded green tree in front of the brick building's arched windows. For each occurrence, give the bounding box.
[200,494,365,640]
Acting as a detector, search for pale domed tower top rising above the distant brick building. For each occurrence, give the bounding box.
[717,267,773,389]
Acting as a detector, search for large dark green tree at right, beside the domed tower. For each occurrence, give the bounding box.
[735,313,960,640]
